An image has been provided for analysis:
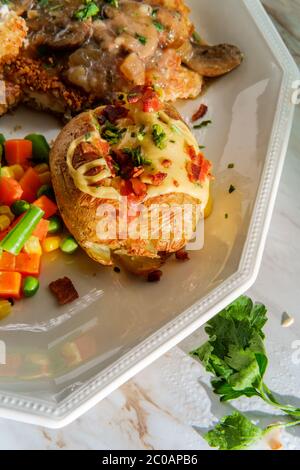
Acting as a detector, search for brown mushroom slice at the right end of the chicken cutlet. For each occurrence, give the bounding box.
[180,42,243,77]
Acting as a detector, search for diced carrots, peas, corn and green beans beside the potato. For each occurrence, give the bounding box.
[0,134,78,320]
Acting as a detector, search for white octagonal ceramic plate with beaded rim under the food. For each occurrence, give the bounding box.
[0,0,298,427]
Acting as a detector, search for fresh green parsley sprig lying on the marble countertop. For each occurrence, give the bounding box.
[191,296,300,449]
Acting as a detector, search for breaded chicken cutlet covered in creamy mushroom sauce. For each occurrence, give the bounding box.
[3,0,243,117]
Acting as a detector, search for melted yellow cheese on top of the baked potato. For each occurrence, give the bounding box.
[67,105,209,210]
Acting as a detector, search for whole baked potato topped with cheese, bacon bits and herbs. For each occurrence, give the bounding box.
[50,87,211,274]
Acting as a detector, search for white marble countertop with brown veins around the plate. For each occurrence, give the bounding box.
[0,0,300,450]
